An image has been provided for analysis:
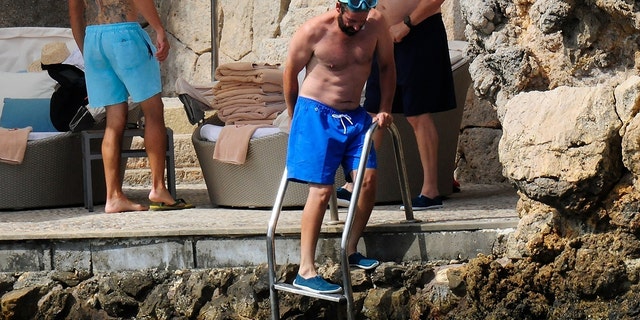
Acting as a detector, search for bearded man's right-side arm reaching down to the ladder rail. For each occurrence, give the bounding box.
[376,13,396,127]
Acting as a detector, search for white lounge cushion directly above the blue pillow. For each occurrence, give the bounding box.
[0,71,57,122]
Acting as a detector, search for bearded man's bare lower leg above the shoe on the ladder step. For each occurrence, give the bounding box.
[298,184,333,279]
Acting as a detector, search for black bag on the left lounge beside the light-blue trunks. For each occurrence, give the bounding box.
[42,63,95,132]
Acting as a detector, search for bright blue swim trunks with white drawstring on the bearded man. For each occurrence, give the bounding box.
[287,97,377,185]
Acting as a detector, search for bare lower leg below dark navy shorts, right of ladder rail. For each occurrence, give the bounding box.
[407,113,440,199]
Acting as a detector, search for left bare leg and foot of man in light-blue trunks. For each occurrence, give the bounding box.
[102,103,148,213]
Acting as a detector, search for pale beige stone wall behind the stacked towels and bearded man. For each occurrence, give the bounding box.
[164,0,465,90]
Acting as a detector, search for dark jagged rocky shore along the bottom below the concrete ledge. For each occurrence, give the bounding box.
[5,251,640,320]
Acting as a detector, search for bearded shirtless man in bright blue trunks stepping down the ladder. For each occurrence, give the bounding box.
[283,0,395,293]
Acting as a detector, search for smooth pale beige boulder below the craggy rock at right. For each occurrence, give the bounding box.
[498,86,622,214]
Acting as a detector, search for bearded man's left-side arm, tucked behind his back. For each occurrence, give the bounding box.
[282,24,313,119]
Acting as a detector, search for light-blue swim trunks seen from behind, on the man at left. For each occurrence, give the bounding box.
[83,22,162,107]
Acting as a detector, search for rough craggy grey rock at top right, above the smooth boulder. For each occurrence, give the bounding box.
[460,0,638,105]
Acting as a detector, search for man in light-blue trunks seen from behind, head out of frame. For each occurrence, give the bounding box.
[69,0,189,213]
